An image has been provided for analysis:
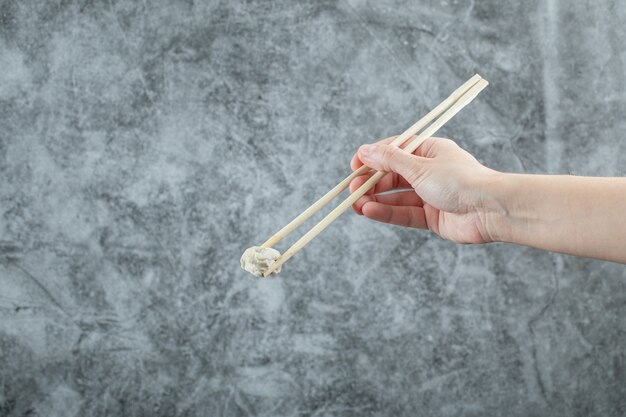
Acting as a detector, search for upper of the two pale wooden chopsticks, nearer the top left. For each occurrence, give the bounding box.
[261,74,482,248]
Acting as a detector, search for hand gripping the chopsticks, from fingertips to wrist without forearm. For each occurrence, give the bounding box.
[350,137,498,243]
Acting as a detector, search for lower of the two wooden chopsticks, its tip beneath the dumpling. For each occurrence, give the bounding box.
[263,78,489,277]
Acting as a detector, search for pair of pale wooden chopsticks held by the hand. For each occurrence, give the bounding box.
[261,74,489,277]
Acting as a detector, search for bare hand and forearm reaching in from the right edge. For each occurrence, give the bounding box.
[350,137,626,263]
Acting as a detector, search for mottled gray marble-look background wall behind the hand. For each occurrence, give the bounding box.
[0,0,626,417]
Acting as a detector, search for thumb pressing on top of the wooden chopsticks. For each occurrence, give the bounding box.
[358,144,427,185]
